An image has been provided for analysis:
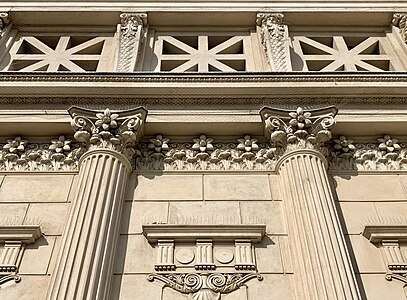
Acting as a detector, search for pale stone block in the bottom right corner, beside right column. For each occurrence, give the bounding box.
[361,274,406,300]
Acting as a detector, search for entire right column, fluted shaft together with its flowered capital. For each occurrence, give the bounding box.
[261,107,360,300]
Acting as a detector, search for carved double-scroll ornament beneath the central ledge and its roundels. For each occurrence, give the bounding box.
[147,273,263,300]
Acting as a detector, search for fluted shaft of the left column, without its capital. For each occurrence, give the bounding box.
[48,149,131,300]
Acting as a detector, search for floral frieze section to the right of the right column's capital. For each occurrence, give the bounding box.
[329,135,407,171]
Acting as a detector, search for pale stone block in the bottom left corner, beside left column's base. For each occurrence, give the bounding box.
[0,275,50,300]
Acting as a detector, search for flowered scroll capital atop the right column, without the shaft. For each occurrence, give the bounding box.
[260,107,338,155]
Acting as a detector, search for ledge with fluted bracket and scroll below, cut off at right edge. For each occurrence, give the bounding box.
[363,225,407,298]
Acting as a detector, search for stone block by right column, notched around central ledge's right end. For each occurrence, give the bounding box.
[240,201,287,234]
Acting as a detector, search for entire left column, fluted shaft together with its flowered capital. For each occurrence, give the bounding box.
[47,107,146,300]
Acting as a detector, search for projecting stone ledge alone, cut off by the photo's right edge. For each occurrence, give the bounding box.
[362,225,407,244]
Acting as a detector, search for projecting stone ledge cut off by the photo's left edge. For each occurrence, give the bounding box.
[0,225,42,245]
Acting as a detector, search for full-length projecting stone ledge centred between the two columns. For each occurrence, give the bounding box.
[143,224,266,243]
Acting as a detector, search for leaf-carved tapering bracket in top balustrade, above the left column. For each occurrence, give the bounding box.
[117,13,147,72]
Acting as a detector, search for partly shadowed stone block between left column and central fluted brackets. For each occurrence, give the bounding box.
[114,235,157,274]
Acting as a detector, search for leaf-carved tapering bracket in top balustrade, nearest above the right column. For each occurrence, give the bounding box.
[256,13,291,72]
